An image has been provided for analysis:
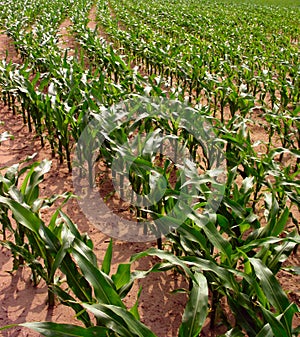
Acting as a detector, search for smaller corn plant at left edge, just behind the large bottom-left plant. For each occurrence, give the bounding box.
[1,160,70,306]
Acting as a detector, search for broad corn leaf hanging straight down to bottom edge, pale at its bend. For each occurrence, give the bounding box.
[179,272,208,337]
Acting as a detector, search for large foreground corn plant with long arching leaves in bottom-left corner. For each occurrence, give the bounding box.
[0,190,159,336]
